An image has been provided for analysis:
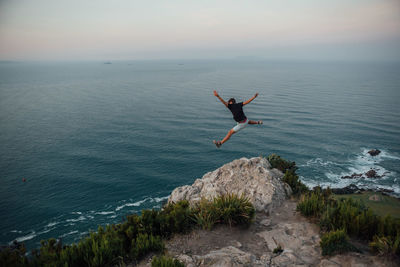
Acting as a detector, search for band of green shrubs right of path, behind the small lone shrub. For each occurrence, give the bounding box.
[297,187,400,255]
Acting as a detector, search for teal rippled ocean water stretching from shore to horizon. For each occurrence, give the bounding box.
[0,60,400,251]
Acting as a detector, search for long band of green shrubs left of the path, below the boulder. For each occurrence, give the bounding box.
[0,194,255,267]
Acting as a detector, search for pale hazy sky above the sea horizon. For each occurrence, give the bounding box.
[0,0,400,61]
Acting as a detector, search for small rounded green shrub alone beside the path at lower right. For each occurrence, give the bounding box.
[320,229,357,255]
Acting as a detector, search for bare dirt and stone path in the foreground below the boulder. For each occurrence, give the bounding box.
[139,200,397,267]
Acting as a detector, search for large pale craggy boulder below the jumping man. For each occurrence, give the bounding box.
[168,157,292,212]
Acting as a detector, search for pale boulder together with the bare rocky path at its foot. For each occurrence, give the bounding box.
[155,158,395,267]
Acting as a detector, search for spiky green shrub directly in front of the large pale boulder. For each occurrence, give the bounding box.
[213,194,255,226]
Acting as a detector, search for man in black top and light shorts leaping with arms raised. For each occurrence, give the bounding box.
[213,90,262,148]
